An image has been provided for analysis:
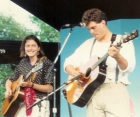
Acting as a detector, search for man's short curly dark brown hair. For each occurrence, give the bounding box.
[82,8,107,25]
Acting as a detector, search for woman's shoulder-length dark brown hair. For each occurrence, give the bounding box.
[20,35,45,58]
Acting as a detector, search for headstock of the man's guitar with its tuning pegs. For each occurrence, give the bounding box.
[121,30,138,43]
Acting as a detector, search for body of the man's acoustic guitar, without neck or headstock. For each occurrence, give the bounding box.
[66,56,106,107]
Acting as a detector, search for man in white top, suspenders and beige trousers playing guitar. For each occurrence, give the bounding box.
[64,8,135,117]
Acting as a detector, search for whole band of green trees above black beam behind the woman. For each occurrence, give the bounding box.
[0,14,59,42]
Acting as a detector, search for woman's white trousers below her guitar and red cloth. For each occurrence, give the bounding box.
[15,99,50,117]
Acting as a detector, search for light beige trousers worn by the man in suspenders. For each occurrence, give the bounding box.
[87,83,130,117]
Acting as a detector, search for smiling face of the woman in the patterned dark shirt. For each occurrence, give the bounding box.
[25,39,40,57]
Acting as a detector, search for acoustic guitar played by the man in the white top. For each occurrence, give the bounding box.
[65,30,138,107]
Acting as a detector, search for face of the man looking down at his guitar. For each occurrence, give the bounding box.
[87,20,106,41]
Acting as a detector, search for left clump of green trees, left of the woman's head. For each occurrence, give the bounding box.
[0,14,31,40]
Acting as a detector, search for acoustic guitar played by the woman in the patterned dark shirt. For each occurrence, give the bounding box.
[1,62,43,117]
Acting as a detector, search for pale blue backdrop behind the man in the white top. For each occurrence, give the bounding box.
[60,19,140,117]
